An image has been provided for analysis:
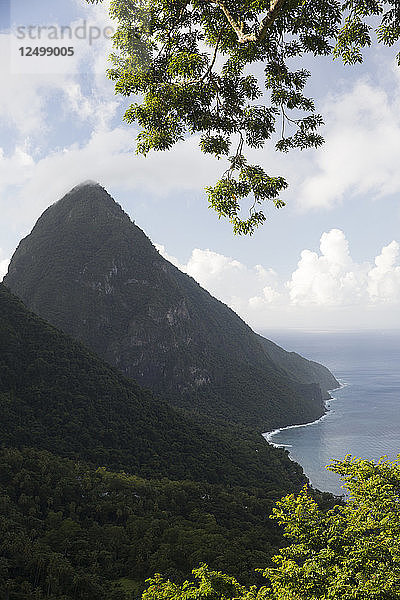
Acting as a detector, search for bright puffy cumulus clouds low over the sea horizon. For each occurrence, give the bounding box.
[157,229,400,329]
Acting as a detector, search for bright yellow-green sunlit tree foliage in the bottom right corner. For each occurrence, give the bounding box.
[143,455,400,600]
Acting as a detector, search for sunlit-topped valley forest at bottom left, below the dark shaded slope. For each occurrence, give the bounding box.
[0,448,310,600]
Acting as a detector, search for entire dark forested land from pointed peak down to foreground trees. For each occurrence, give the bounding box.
[0,184,336,600]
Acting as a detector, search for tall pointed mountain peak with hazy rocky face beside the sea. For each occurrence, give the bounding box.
[4,183,335,431]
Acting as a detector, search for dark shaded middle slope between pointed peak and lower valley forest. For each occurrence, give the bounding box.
[0,284,305,490]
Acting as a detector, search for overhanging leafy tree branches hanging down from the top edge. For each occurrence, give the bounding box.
[87,0,400,234]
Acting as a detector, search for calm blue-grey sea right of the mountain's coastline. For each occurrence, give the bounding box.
[264,331,400,494]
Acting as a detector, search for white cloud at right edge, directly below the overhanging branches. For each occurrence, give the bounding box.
[298,79,400,209]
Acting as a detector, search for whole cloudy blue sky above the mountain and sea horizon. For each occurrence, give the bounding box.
[0,0,400,332]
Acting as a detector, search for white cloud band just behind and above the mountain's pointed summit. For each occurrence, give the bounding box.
[0,127,220,238]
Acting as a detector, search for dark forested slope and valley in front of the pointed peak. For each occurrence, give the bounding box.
[0,284,330,600]
